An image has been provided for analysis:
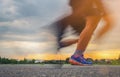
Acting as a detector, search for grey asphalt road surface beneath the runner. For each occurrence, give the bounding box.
[0,65,120,77]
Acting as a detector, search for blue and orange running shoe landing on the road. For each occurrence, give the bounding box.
[69,55,92,66]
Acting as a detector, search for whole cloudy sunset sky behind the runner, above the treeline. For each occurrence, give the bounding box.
[0,0,120,59]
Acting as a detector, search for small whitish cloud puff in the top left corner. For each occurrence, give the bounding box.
[0,0,18,22]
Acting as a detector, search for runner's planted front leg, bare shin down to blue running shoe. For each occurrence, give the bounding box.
[69,16,100,65]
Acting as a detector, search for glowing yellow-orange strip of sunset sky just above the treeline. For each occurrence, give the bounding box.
[15,50,120,60]
